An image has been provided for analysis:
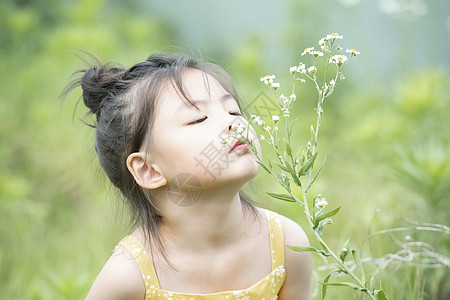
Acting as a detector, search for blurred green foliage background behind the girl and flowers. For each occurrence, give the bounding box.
[0,0,450,299]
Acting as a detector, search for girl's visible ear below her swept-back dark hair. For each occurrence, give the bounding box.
[127,152,167,189]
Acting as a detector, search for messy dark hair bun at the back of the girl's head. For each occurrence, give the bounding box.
[80,66,125,116]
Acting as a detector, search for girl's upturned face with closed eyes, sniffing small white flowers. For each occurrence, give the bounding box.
[149,69,261,188]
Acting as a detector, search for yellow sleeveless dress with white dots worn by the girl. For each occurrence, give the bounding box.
[119,210,286,300]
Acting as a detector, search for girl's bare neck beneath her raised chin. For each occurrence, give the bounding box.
[150,186,255,253]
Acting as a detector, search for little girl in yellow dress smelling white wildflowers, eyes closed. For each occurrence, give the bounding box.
[69,55,311,300]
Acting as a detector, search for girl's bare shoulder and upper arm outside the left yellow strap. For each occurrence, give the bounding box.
[86,246,145,300]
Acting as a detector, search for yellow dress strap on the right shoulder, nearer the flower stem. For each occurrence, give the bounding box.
[265,210,284,270]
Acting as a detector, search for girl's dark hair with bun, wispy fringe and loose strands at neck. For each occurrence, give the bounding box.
[63,54,256,260]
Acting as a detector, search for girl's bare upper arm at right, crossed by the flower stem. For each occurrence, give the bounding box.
[278,216,312,300]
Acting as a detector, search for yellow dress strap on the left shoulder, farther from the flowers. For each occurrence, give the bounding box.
[119,235,159,291]
